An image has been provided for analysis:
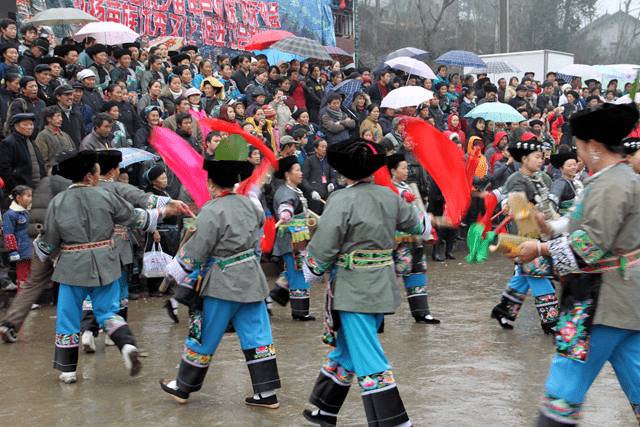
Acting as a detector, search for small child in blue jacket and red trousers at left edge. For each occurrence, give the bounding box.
[2,185,33,292]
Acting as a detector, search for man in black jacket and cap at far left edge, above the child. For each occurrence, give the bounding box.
[0,113,45,193]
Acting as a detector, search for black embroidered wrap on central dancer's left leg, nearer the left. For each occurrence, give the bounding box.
[309,359,356,414]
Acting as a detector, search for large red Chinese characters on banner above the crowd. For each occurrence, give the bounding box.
[74,0,280,50]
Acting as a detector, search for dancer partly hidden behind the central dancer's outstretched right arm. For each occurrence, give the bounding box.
[387,153,440,324]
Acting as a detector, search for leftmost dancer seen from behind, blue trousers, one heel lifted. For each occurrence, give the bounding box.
[34,150,168,383]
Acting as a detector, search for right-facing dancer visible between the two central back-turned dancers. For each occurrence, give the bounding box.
[269,156,316,321]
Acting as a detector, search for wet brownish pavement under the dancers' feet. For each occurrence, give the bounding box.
[0,253,637,427]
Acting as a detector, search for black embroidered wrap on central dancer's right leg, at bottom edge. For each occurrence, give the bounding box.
[358,370,409,427]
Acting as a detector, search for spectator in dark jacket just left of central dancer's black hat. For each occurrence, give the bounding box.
[300,138,338,215]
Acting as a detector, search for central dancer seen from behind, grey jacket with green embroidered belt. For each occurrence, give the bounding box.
[303,139,431,427]
